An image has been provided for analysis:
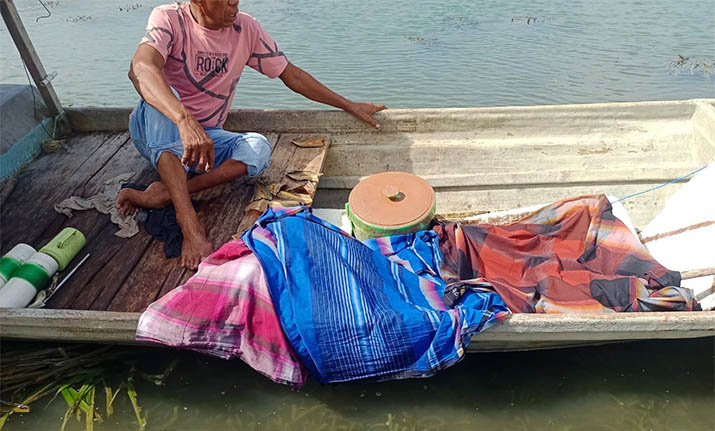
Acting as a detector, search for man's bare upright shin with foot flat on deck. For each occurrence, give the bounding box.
[157,152,213,269]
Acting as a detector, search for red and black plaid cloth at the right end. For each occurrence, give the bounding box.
[434,195,699,313]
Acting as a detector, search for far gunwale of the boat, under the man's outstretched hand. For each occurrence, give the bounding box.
[65,98,715,134]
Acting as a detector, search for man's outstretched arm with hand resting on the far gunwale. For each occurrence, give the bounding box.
[278,62,387,128]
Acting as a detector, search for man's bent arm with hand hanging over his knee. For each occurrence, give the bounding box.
[129,44,214,172]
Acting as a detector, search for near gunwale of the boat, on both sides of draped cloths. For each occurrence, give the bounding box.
[0,308,715,351]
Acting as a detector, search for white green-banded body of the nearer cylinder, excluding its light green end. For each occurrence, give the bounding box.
[0,252,59,308]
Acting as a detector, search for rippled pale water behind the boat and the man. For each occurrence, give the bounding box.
[0,0,715,109]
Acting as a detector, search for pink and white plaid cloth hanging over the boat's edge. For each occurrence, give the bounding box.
[137,240,306,387]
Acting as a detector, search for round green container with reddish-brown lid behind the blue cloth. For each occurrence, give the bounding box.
[345,172,437,241]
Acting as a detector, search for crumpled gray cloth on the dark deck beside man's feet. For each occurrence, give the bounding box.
[55,172,139,238]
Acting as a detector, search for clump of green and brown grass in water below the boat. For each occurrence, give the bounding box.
[0,343,177,431]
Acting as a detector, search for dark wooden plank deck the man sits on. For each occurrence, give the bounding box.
[0,132,330,312]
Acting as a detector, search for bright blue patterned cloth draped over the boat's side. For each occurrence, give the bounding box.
[242,207,508,383]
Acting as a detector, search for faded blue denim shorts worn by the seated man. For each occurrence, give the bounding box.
[129,100,271,177]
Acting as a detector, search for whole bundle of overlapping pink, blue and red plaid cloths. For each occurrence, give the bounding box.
[137,195,699,387]
